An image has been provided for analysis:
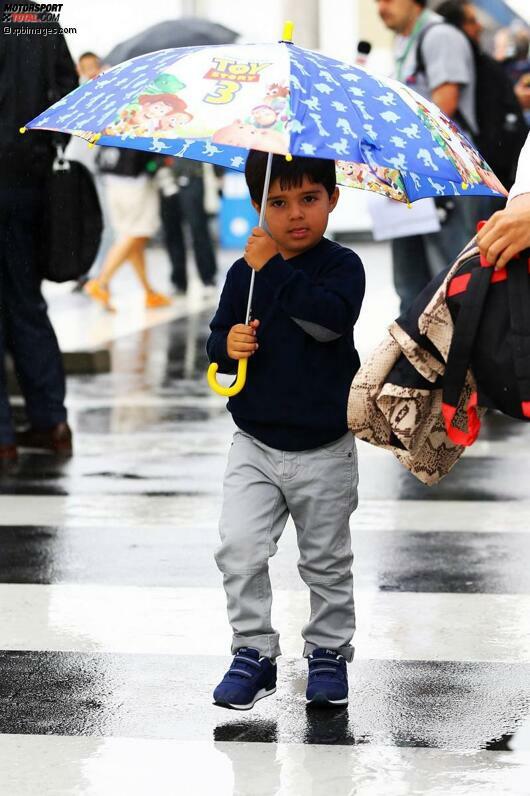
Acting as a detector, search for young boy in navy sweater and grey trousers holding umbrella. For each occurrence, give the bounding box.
[207,151,364,710]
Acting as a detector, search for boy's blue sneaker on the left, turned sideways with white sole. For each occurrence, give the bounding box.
[213,647,276,710]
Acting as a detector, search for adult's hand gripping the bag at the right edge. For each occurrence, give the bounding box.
[477,193,530,268]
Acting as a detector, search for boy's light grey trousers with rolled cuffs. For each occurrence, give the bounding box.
[215,431,358,661]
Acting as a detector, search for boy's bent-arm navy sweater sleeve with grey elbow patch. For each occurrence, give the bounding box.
[261,252,365,343]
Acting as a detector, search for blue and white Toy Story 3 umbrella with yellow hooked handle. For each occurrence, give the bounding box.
[22,23,505,395]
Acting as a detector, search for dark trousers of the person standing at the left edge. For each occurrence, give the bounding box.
[0,183,66,444]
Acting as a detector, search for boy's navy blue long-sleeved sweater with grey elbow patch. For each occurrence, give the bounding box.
[207,238,365,451]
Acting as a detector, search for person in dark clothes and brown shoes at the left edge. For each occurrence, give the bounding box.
[0,3,77,462]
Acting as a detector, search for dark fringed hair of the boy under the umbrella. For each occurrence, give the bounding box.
[245,149,337,205]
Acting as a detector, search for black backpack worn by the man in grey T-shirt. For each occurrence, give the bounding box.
[413,22,528,189]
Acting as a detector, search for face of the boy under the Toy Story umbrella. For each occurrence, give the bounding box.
[252,177,339,260]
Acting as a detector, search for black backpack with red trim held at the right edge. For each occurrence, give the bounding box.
[442,250,530,445]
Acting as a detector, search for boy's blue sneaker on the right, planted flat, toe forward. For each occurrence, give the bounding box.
[306,647,348,706]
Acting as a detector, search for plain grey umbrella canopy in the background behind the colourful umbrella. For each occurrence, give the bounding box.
[103,17,239,66]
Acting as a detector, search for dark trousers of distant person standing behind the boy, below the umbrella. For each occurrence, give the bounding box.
[161,177,217,290]
